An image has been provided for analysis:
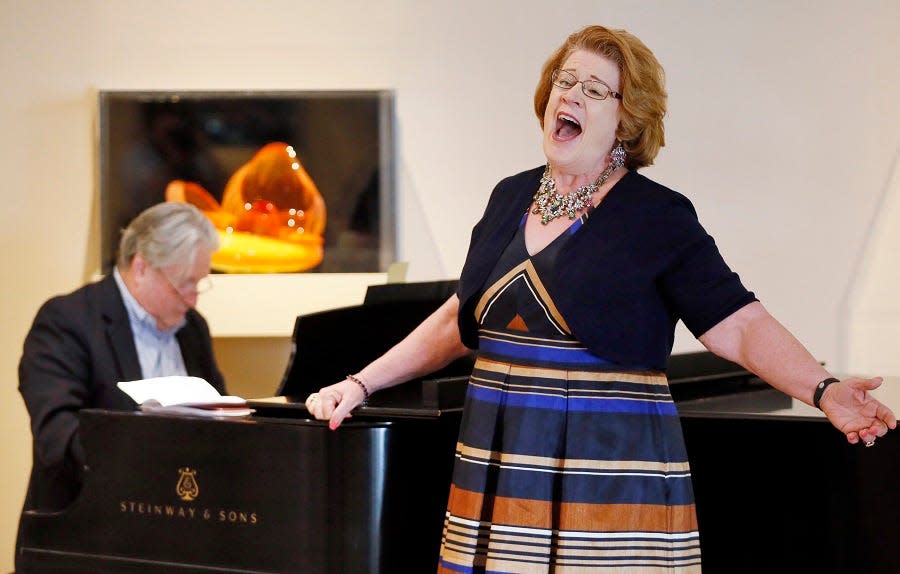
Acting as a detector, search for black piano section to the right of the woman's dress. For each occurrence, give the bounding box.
[675,378,900,574]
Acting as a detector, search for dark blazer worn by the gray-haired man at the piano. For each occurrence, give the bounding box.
[19,275,225,510]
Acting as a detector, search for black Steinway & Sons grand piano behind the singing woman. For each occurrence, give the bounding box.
[17,281,900,574]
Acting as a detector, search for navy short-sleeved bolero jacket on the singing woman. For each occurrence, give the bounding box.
[457,166,756,370]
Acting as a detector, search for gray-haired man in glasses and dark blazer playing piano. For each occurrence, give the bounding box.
[17,202,226,568]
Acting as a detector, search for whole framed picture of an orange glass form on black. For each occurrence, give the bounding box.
[99,90,396,273]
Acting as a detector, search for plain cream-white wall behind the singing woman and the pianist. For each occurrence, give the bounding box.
[0,0,900,569]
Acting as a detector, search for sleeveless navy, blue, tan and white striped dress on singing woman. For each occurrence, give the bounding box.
[438,214,700,574]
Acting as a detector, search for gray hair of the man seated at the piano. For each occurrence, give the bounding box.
[117,205,219,271]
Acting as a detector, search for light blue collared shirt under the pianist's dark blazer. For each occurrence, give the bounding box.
[113,267,187,379]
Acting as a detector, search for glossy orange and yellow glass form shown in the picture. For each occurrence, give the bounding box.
[166,142,326,273]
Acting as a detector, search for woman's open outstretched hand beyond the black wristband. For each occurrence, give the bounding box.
[819,377,897,445]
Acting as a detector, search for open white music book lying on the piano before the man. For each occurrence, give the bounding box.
[117,376,253,416]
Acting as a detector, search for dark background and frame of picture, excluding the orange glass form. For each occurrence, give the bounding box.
[98,90,397,273]
